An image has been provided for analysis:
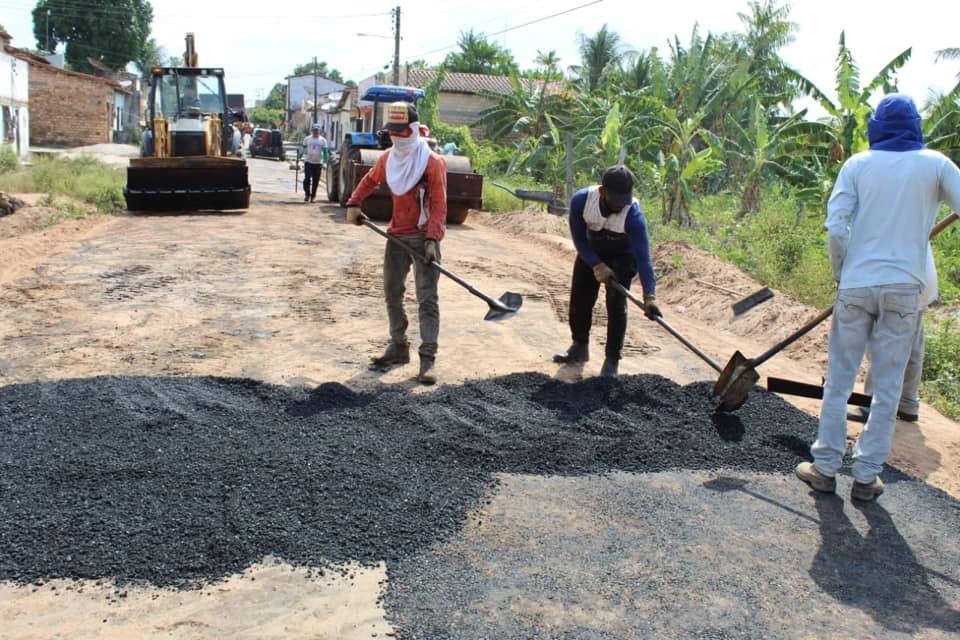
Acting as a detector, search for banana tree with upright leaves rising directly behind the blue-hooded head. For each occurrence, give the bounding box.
[784,31,912,167]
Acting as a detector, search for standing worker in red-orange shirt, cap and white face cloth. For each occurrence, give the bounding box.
[347,102,447,384]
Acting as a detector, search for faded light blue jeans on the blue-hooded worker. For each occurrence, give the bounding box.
[810,284,920,483]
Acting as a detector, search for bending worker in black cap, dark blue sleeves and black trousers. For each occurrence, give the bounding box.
[553,165,662,378]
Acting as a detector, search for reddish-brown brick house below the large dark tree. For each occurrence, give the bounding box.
[27,57,125,147]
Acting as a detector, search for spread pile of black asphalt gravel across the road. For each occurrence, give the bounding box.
[0,374,816,587]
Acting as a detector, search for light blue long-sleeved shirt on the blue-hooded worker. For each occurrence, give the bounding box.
[825,149,960,289]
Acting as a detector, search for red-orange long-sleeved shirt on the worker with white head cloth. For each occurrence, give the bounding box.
[347,150,447,240]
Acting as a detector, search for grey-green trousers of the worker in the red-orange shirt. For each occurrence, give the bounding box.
[383,236,440,359]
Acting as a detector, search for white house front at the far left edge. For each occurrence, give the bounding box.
[0,30,30,160]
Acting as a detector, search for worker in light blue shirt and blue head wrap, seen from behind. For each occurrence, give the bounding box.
[796,94,960,500]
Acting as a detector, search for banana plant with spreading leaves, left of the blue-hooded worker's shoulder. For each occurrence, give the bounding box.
[728,99,833,220]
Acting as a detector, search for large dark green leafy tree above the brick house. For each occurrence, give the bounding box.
[33,0,153,73]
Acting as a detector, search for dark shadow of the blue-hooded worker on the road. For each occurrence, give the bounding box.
[810,494,960,634]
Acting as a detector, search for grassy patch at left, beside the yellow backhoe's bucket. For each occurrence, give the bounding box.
[0,156,126,217]
